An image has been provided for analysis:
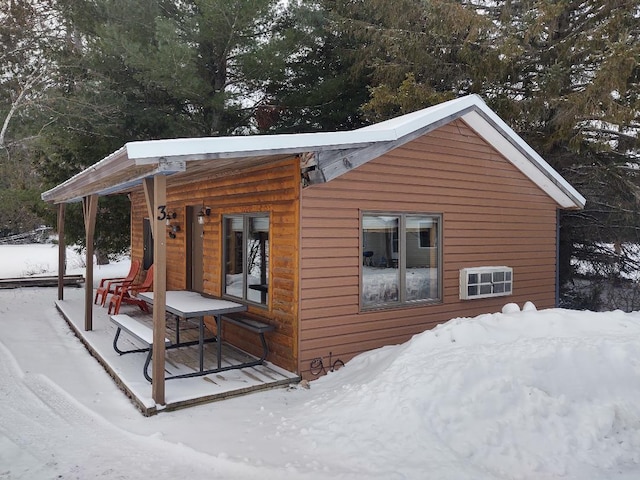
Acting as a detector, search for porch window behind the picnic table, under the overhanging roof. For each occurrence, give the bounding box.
[223,214,269,305]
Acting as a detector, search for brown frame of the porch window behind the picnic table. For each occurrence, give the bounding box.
[220,212,272,310]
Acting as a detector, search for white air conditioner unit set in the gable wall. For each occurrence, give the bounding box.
[460,267,513,300]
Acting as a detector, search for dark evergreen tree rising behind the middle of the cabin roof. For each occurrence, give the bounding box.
[257,0,370,133]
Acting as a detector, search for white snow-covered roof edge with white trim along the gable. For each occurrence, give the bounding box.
[42,94,586,208]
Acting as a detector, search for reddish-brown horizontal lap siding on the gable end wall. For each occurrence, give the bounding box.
[299,121,557,377]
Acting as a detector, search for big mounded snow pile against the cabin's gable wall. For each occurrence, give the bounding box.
[281,304,640,478]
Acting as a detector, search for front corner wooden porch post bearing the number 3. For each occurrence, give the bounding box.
[152,175,167,405]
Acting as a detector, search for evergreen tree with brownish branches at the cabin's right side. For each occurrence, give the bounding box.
[473,0,640,306]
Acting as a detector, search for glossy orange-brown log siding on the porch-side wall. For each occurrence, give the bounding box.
[131,158,300,371]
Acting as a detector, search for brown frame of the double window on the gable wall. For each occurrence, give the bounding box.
[358,210,444,313]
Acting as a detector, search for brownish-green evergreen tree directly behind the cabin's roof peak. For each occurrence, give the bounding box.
[333,0,497,122]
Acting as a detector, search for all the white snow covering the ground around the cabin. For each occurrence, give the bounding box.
[0,245,640,480]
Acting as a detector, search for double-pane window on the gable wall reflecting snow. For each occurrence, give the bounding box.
[362,213,441,308]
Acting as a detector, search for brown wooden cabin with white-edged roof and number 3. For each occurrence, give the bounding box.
[42,95,585,402]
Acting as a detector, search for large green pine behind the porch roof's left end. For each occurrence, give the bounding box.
[38,0,292,258]
